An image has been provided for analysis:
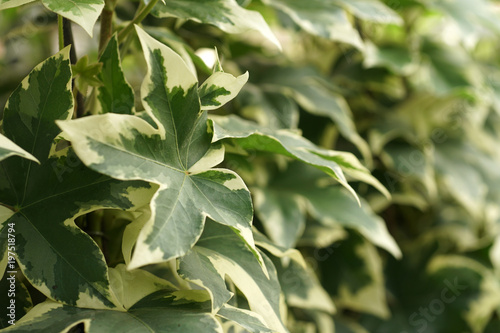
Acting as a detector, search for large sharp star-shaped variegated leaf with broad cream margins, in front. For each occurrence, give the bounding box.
[59,28,259,267]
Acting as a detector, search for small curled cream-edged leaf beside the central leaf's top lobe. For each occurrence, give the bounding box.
[199,72,248,111]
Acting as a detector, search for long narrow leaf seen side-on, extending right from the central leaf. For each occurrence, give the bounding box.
[210,115,390,198]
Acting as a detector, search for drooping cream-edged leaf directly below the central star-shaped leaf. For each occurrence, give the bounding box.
[179,222,287,332]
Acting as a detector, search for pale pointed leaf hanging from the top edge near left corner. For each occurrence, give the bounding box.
[41,0,104,37]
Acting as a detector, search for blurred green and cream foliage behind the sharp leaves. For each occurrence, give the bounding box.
[0,0,500,333]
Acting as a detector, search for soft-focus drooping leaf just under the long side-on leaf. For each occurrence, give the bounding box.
[255,163,401,257]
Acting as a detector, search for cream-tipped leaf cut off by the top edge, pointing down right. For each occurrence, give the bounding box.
[153,0,281,49]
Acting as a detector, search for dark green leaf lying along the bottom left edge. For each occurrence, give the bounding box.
[6,291,222,333]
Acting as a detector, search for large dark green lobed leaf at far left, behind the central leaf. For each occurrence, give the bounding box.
[0,48,149,307]
